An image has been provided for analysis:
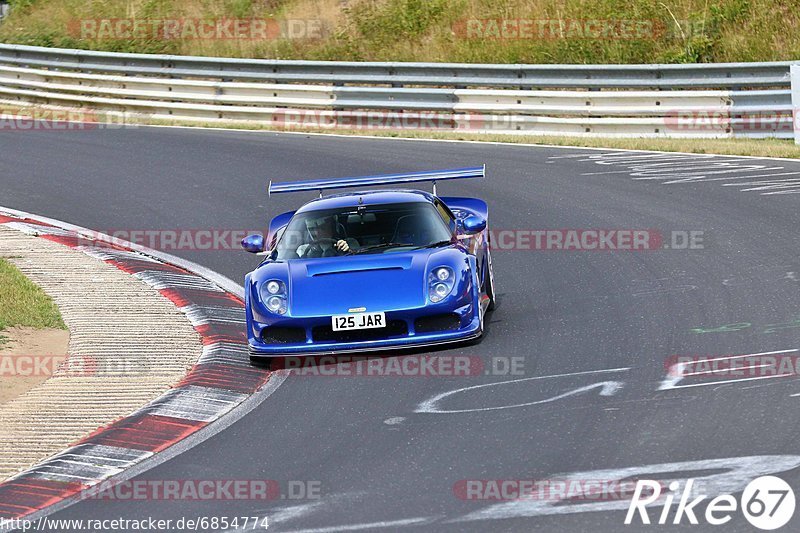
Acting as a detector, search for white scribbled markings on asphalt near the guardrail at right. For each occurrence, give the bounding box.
[548,152,800,196]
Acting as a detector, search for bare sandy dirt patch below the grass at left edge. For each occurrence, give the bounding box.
[0,327,69,405]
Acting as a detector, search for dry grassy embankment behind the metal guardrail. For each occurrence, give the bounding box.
[0,0,800,63]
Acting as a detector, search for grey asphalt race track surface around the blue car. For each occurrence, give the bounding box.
[0,128,800,532]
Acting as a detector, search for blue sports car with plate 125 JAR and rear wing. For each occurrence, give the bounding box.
[242,167,495,361]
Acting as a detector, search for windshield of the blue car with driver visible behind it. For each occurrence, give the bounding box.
[275,202,451,260]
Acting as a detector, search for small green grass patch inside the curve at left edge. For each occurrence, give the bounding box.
[0,259,67,344]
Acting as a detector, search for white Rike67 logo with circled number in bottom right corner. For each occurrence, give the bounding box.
[625,476,795,530]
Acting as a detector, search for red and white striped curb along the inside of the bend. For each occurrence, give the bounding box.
[0,210,270,518]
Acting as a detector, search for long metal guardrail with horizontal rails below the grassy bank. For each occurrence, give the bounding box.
[0,45,794,138]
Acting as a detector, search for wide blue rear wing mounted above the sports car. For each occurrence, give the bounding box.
[268,165,486,196]
